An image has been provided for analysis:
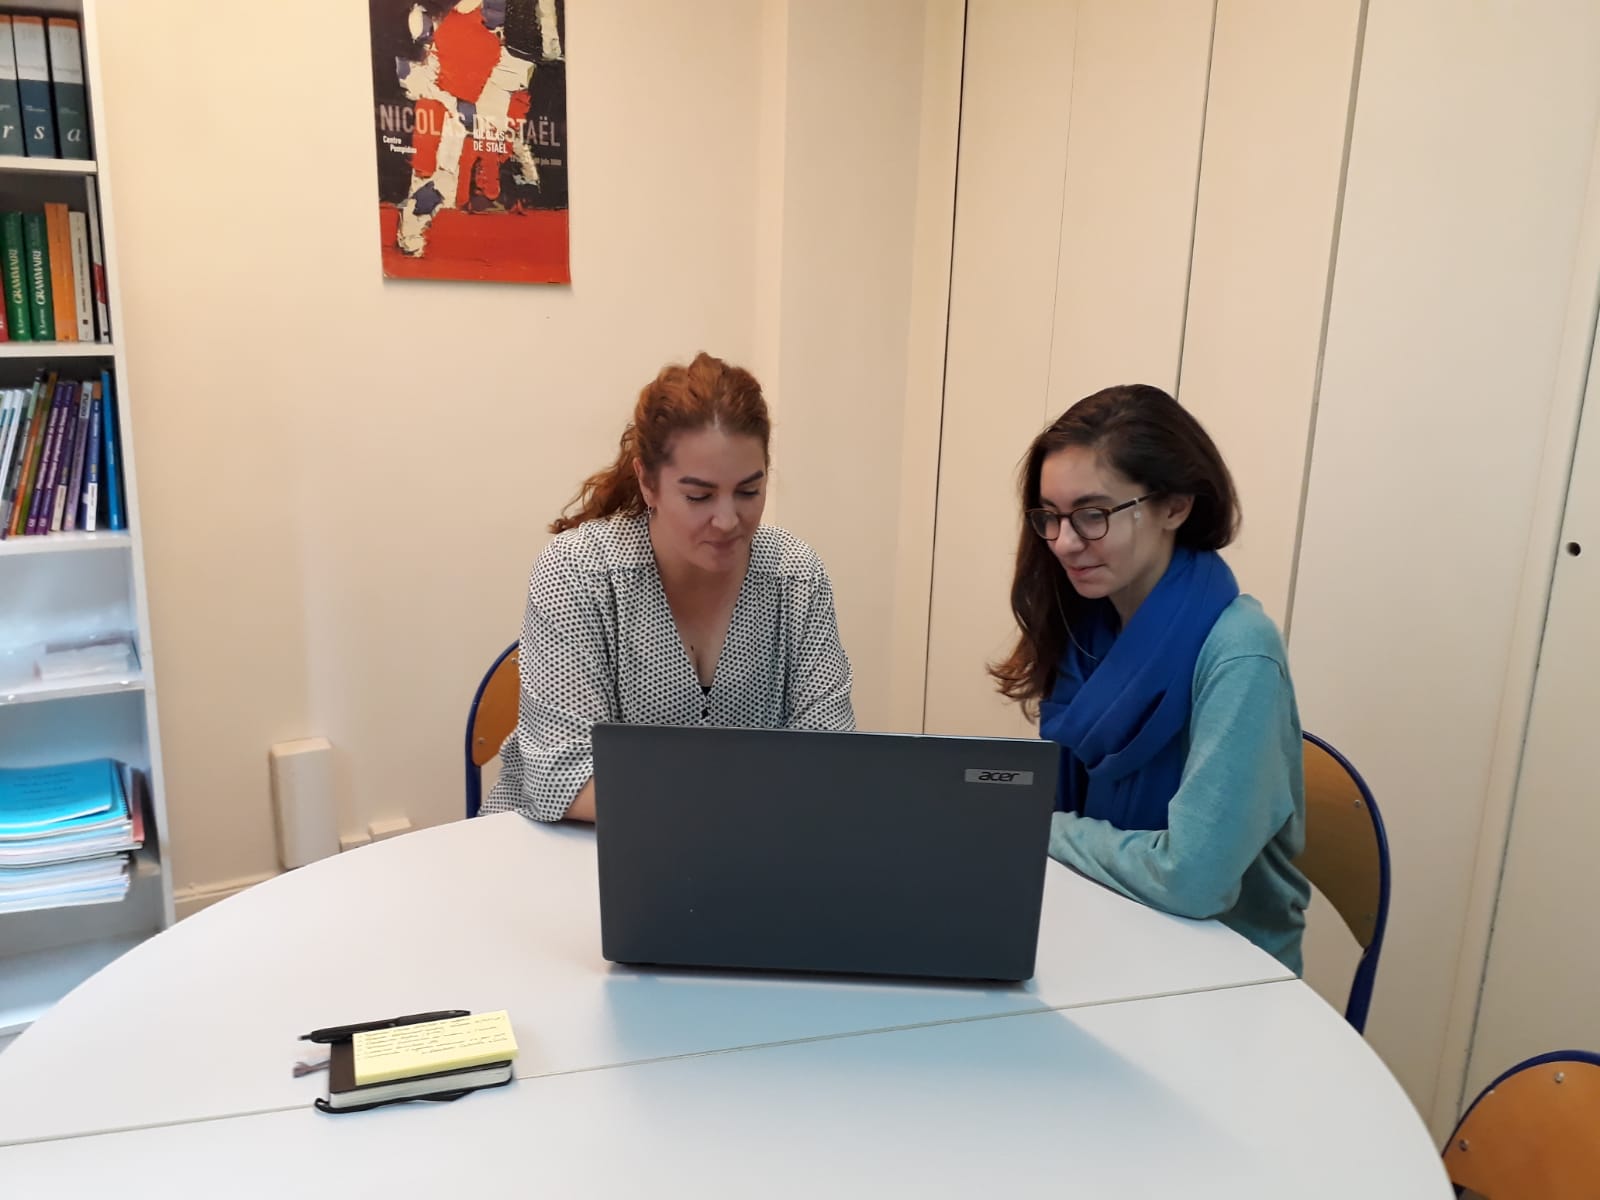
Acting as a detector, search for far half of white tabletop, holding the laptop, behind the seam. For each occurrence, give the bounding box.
[0,814,1290,1146]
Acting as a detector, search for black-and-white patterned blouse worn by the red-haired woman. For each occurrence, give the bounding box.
[483,515,856,821]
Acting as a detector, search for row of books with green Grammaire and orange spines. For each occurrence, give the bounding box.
[0,203,110,342]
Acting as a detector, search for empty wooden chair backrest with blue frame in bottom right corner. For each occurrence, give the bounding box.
[1445,1050,1600,1200]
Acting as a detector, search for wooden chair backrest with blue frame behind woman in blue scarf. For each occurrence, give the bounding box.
[1296,733,1389,1032]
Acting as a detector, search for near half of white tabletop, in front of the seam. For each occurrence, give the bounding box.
[0,982,1453,1200]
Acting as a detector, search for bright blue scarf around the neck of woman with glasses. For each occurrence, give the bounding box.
[1038,547,1238,829]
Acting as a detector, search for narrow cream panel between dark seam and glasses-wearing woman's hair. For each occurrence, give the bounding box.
[926,0,1075,736]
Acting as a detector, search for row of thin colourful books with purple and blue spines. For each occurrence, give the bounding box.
[0,371,128,538]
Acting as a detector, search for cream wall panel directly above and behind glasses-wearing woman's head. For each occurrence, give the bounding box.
[1178,0,1362,624]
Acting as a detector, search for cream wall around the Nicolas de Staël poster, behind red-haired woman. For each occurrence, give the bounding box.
[101,0,960,888]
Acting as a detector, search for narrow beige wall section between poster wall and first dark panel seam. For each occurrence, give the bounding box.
[773,0,962,728]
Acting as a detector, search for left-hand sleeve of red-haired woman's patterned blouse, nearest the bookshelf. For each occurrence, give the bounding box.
[485,542,621,821]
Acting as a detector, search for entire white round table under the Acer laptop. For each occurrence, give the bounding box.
[0,814,1451,1200]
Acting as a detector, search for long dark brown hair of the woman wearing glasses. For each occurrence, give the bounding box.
[989,384,1238,717]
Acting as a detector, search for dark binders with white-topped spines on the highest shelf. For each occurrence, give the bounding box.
[0,13,91,158]
